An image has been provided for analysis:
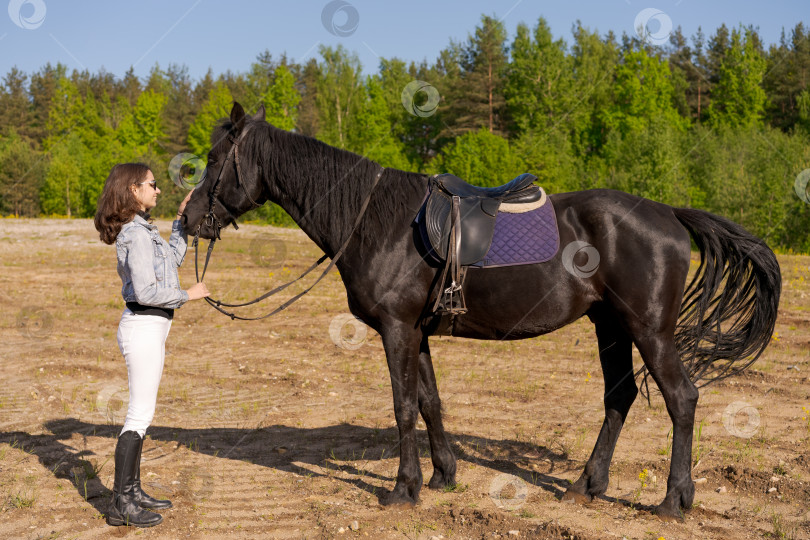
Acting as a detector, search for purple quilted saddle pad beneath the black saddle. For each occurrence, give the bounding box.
[473,199,560,268]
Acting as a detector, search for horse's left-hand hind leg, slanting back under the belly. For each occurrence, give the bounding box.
[562,319,638,502]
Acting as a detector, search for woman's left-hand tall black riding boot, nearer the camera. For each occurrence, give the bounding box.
[107,431,163,527]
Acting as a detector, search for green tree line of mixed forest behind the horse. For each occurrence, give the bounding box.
[0,15,810,252]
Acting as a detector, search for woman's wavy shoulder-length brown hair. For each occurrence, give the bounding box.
[93,163,150,244]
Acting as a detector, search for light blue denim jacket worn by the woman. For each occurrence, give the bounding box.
[115,215,188,308]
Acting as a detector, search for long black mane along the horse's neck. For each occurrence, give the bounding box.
[214,120,427,250]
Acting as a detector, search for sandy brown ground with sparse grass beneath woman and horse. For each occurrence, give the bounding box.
[0,219,810,540]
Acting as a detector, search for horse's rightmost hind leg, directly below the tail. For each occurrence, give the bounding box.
[635,331,699,520]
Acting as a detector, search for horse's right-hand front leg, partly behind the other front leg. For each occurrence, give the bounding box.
[419,336,456,489]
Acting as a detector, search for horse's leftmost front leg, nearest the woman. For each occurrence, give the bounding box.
[380,322,422,506]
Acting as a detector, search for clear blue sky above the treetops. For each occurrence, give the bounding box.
[0,0,810,79]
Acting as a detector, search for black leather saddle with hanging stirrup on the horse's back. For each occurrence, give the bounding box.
[420,173,546,315]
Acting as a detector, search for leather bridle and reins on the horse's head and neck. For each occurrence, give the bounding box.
[194,129,385,321]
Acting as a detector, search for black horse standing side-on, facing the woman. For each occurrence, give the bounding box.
[183,103,781,519]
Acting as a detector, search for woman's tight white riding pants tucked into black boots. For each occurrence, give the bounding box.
[118,309,172,438]
